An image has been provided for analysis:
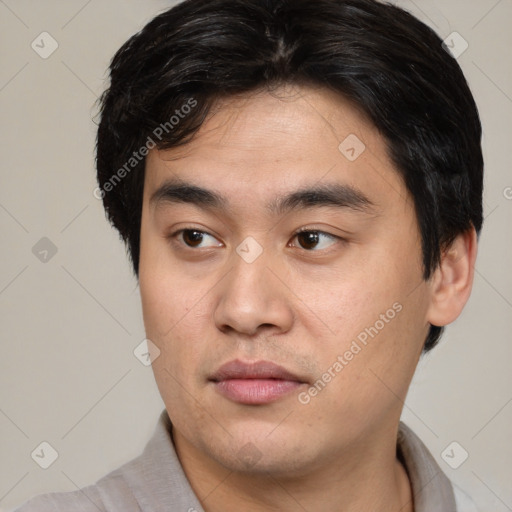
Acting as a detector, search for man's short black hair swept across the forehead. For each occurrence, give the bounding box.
[95,0,483,351]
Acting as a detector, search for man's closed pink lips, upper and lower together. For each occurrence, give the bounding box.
[209,359,307,405]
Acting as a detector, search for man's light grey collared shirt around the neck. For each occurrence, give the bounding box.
[15,409,476,512]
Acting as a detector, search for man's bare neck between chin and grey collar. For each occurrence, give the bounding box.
[173,422,414,512]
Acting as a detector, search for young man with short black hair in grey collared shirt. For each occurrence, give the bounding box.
[13,0,483,512]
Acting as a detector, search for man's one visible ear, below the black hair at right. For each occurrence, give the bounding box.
[427,227,477,327]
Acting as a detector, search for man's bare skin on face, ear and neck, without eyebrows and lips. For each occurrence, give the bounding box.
[139,87,476,512]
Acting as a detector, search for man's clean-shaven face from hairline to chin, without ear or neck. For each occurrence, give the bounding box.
[139,88,430,475]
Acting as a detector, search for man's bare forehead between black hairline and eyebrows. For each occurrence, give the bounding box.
[144,87,407,212]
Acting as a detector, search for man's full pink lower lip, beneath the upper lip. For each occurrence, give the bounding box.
[215,379,302,405]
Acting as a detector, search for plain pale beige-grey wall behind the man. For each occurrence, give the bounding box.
[0,0,512,512]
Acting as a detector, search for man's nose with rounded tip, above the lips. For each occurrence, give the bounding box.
[214,247,294,336]
